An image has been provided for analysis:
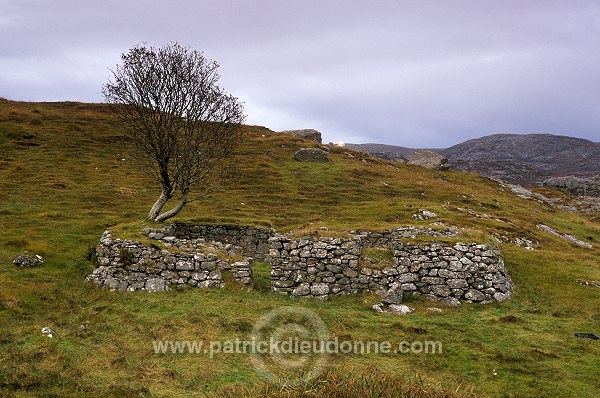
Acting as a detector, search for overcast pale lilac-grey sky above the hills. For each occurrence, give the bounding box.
[0,0,600,147]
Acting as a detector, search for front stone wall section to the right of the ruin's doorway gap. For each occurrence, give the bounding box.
[269,234,514,305]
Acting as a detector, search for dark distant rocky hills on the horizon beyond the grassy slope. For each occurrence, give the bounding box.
[346,134,600,186]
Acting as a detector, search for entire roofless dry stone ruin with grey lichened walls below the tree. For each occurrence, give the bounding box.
[87,224,514,305]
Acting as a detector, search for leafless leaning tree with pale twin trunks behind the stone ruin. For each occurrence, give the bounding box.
[102,43,245,221]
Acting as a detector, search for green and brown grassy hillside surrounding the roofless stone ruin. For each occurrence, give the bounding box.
[0,100,600,397]
